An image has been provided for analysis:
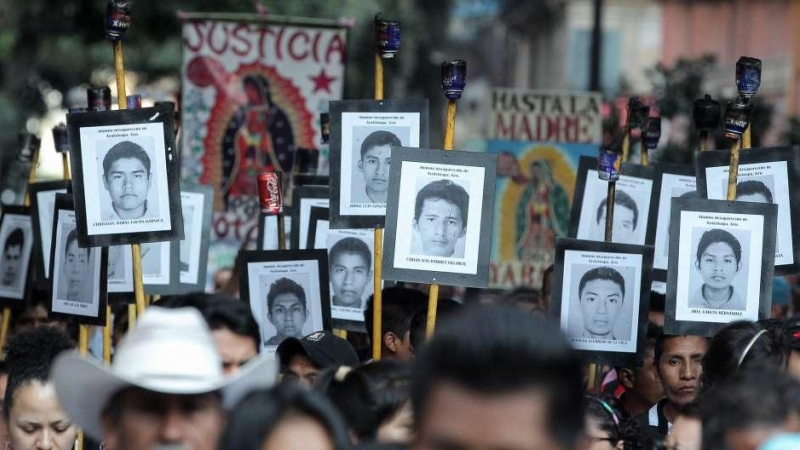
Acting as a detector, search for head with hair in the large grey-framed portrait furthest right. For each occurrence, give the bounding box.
[694,229,742,289]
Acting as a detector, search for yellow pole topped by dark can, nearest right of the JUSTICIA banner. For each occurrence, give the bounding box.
[370,13,401,361]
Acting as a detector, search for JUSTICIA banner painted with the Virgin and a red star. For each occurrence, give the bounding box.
[181,20,347,288]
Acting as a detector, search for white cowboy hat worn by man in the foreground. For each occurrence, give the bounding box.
[52,306,278,439]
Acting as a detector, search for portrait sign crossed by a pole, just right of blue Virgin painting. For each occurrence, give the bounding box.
[569,156,653,245]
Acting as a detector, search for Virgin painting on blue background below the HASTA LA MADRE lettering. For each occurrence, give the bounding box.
[488,140,597,289]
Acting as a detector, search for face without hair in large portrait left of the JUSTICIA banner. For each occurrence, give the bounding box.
[103,158,150,218]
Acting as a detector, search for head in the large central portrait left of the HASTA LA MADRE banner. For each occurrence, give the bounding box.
[414,180,469,257]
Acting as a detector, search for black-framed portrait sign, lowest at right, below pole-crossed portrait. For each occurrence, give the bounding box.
[550,238,653,365]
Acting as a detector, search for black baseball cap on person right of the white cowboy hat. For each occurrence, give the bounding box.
[276,331,358,369]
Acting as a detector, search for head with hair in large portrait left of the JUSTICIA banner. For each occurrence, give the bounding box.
[103,141,152,219]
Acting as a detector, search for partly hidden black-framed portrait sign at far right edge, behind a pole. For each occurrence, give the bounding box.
[695,147,800,275]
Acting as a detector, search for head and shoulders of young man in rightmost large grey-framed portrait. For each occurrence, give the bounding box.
[689,229,745,311]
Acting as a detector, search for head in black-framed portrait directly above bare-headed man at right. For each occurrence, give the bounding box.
[578,267,625,337]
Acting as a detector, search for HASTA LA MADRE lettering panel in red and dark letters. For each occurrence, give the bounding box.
[488,88,603,143]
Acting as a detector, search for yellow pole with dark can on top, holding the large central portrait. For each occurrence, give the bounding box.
[425,59,467,339]
